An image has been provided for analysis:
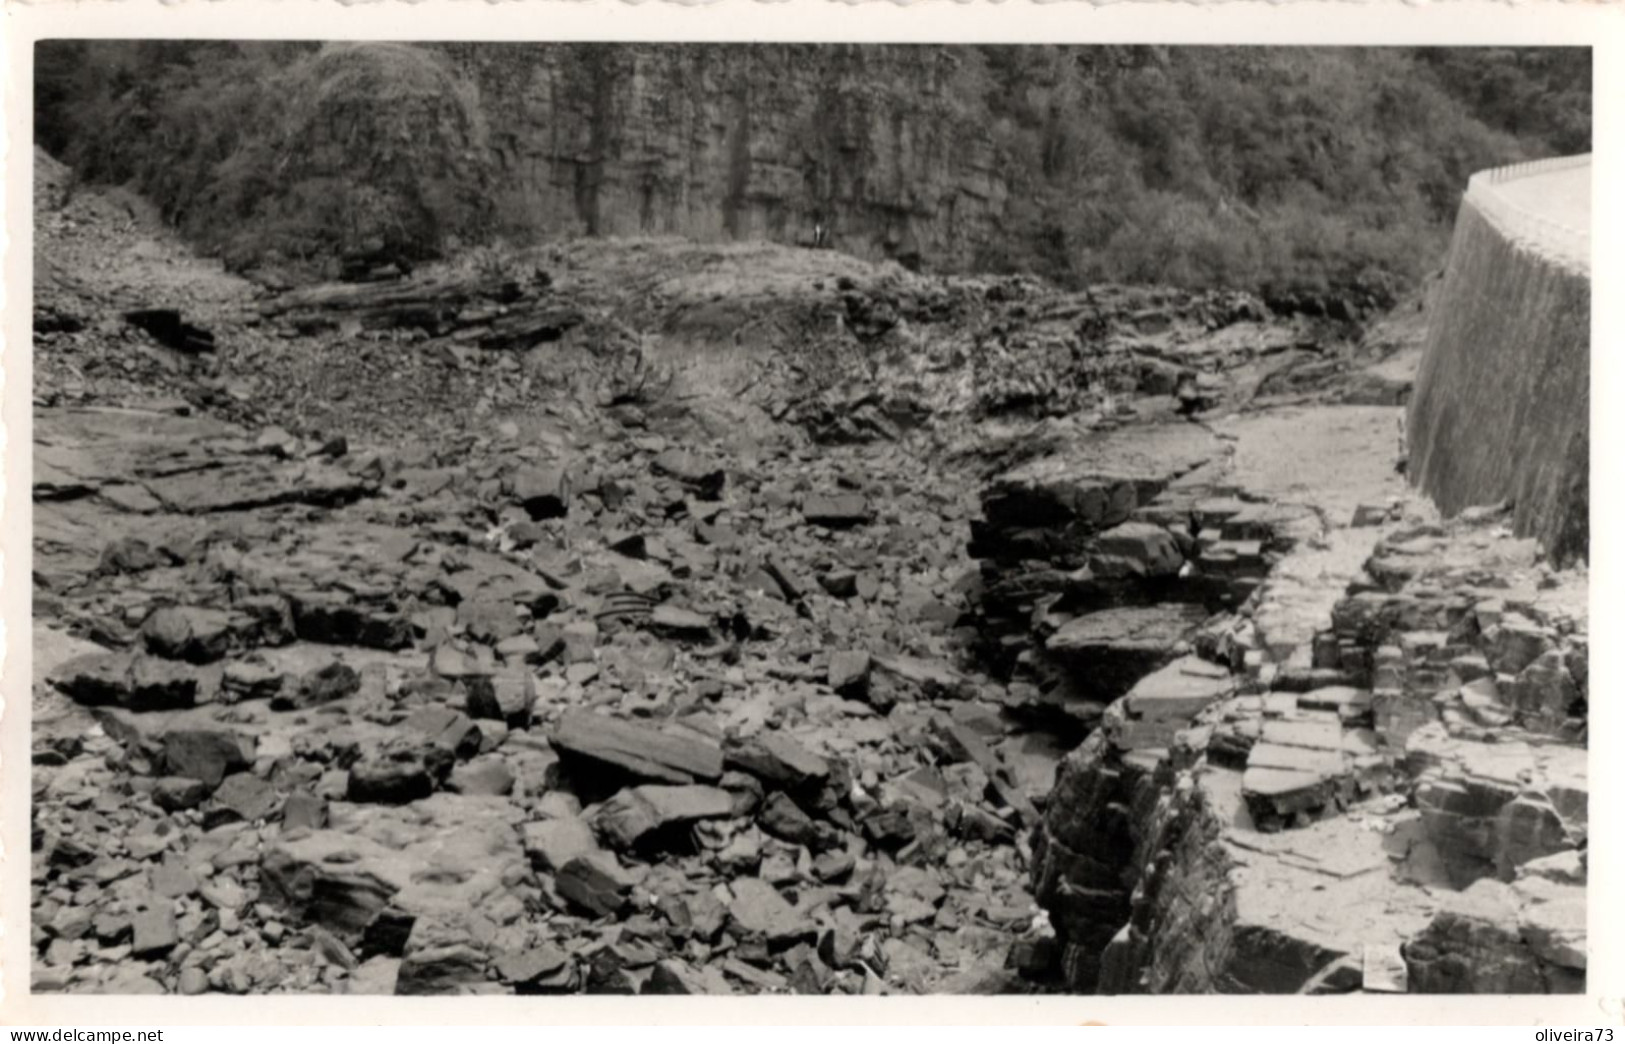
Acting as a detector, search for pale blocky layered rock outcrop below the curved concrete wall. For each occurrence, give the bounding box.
[1014,435,1588,994]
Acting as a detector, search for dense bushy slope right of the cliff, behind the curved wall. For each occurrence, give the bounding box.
[964,47,1591,291]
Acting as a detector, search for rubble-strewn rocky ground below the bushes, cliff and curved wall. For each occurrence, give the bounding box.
[33,158,1588,994]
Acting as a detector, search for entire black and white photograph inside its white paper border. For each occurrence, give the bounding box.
[7,26,1617,1003]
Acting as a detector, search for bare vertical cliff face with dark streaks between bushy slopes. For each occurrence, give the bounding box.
[447,44,1009,268]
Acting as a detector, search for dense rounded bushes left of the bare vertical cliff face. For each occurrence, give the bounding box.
[41,42,489,273]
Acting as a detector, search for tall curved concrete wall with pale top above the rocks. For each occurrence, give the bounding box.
[1407,156,1591,559]
